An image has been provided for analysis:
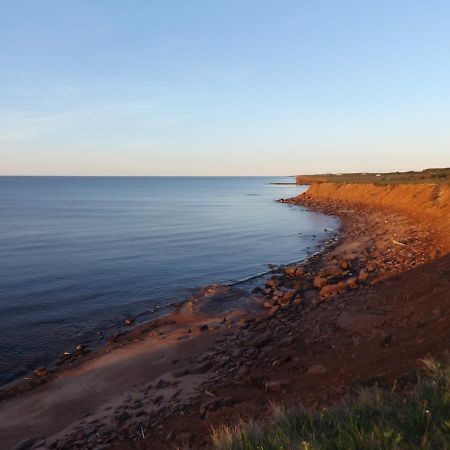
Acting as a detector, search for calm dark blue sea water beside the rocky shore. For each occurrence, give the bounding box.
[0,177,336,383]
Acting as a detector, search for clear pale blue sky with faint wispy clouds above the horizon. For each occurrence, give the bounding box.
[0,0,450,175]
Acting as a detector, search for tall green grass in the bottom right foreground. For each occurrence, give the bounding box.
[213,361,450,450]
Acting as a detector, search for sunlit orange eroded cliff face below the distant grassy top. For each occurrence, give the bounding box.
[297,181,450,252]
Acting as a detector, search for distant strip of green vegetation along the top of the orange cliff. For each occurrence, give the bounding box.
[297,168,450,184]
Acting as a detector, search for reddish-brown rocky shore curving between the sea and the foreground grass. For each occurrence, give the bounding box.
[0,184,450,450]
